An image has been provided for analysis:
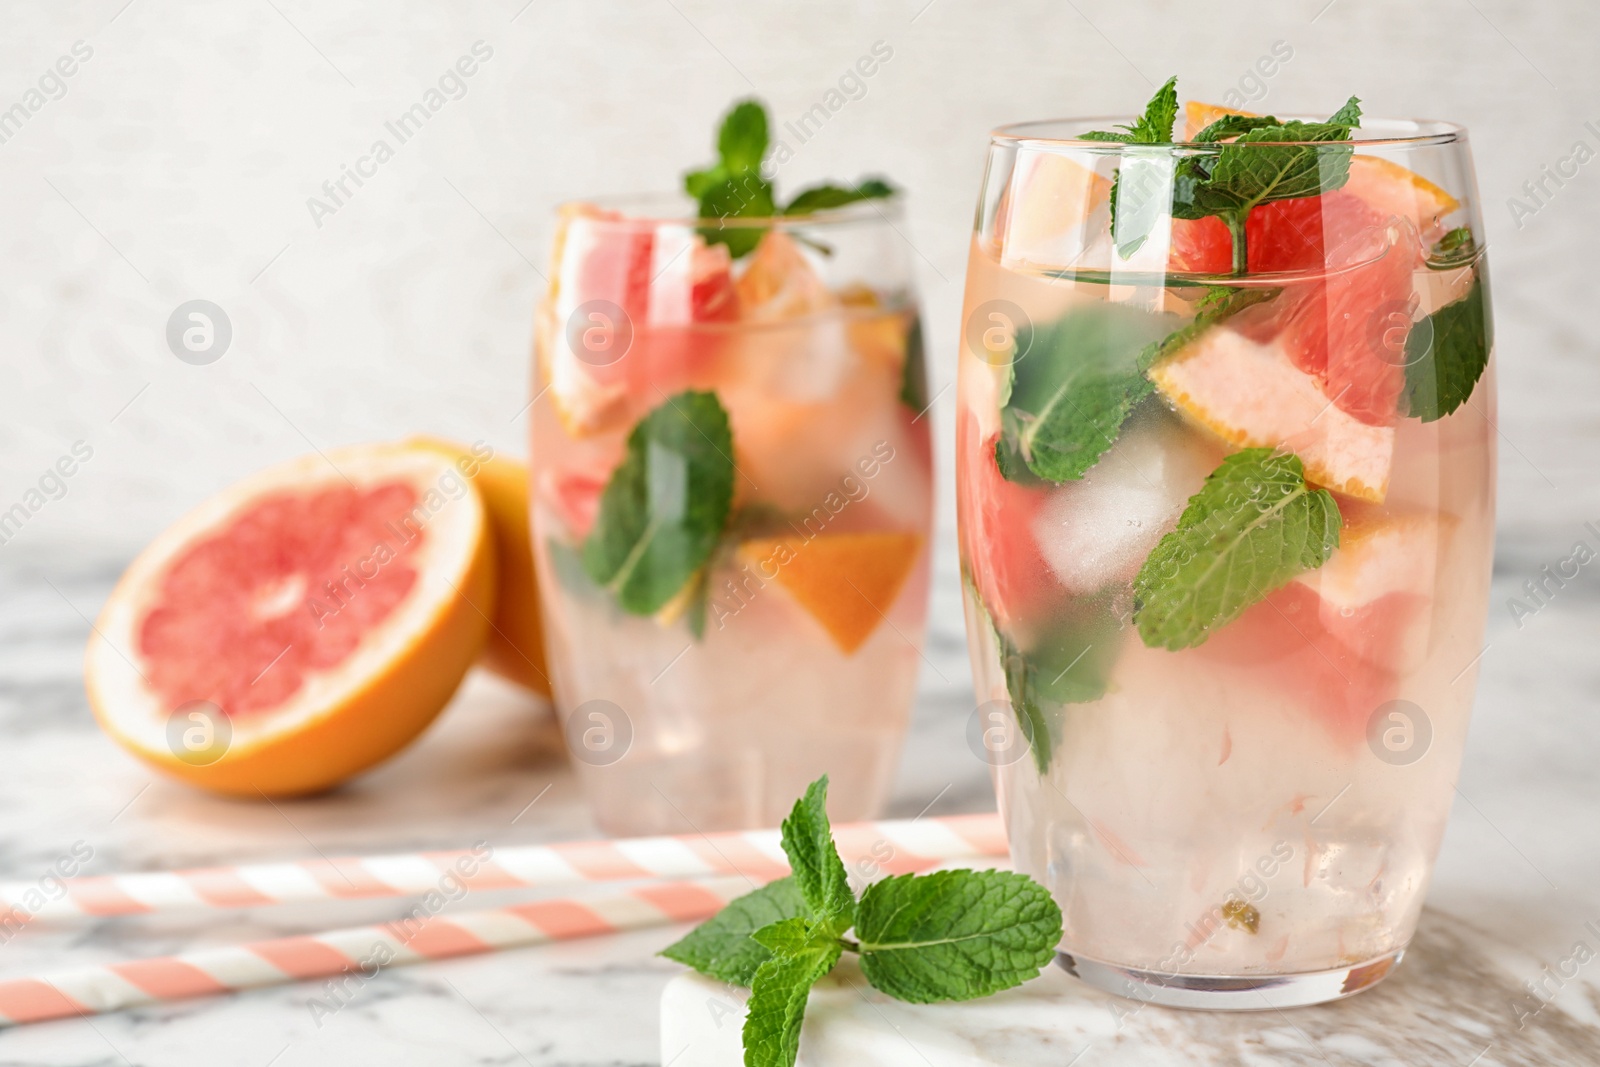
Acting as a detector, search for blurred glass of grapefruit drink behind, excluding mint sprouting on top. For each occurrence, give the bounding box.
[531,119,931,835]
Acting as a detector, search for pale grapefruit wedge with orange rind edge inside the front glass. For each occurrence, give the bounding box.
[1150,325,1395,504]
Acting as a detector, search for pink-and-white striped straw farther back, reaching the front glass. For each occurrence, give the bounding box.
[0,814,1006,929]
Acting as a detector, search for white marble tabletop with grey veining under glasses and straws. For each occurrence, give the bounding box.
[0,545,1600,1067]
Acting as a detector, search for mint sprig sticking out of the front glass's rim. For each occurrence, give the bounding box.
[1078,78,1362,274]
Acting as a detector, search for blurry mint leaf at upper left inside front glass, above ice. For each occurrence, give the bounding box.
[995,302,1173,483]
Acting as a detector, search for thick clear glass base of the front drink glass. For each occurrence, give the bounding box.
[1056,949,1405,1011]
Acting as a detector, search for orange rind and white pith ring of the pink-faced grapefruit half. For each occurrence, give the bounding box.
[85,445,494,797]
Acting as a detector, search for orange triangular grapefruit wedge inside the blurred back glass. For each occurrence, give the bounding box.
[739,533,922,656]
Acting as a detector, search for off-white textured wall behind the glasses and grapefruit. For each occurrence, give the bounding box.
[0,0,1600,574]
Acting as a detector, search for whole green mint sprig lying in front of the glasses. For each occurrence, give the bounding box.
[661,776,1061,1067]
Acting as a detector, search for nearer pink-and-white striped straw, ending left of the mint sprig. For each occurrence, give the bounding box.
[0,878,750,1025]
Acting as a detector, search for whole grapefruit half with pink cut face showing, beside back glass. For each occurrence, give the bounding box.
[85,445,494,797]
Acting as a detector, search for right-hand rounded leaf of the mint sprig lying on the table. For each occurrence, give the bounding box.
[856,870,1061,1005]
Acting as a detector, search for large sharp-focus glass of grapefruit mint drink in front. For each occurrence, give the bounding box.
[957,83,1494,1011]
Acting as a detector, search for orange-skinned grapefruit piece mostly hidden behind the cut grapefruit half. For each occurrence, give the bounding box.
[413,437,550,696]
